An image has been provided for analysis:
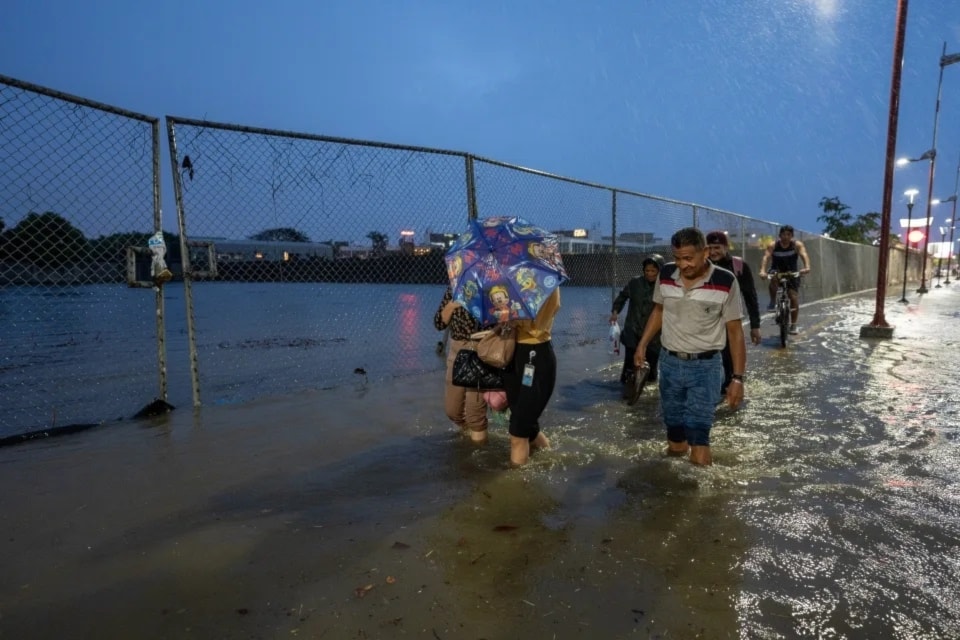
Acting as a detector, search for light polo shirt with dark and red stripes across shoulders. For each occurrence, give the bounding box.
[653,262,743,353]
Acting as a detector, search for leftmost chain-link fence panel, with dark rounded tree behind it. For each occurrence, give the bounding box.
[0,76,167,438]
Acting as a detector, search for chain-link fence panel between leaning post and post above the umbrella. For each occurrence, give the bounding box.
[167,117,476,403]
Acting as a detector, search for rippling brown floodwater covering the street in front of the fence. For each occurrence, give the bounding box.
[0,285,960,639]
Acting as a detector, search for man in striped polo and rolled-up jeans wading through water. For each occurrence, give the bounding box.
[633,227,747,465]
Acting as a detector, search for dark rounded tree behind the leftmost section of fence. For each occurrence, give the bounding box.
[3,211,90,267]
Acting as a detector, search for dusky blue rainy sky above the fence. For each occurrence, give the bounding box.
[0,0,960,238]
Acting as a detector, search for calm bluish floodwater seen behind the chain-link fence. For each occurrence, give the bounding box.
[0,282,612,438]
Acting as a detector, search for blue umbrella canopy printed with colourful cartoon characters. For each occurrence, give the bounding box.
[445,216,568,325]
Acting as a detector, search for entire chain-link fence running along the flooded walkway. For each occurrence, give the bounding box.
[0,76,919,437]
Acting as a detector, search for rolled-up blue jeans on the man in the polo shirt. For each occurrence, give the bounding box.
[660,349,723,446]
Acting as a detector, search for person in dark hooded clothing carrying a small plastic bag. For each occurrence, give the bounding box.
[610,256,663,391]
